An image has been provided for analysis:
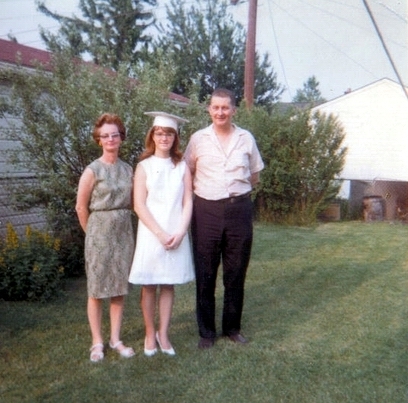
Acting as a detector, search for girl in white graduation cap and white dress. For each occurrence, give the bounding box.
[129,112,194,356]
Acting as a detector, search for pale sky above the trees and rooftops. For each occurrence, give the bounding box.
[0,0,408,102]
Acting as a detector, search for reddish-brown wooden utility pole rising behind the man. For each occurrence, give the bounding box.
[244,0,258,109]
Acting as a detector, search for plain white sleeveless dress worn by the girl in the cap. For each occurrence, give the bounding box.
[129,156,194,285]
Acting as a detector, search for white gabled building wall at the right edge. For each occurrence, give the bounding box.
[313,79,408,181]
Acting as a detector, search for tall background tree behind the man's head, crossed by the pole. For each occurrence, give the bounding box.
[153,0,283,105]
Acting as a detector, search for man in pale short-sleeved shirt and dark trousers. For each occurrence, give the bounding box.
[185,88,264,348]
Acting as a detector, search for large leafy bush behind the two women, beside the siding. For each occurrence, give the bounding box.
[0,54,206,274]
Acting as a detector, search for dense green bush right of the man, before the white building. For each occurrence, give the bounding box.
[237,108,346,225]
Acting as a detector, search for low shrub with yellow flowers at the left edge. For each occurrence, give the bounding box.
[0,224,64,301]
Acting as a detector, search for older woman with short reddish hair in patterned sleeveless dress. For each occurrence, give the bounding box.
[76,113,135,362]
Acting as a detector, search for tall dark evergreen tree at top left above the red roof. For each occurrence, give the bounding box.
[37,0,157,70]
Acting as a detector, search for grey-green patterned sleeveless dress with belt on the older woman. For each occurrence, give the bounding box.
[85,159,135,298]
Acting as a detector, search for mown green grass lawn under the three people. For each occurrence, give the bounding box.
[0,222,408,403]
